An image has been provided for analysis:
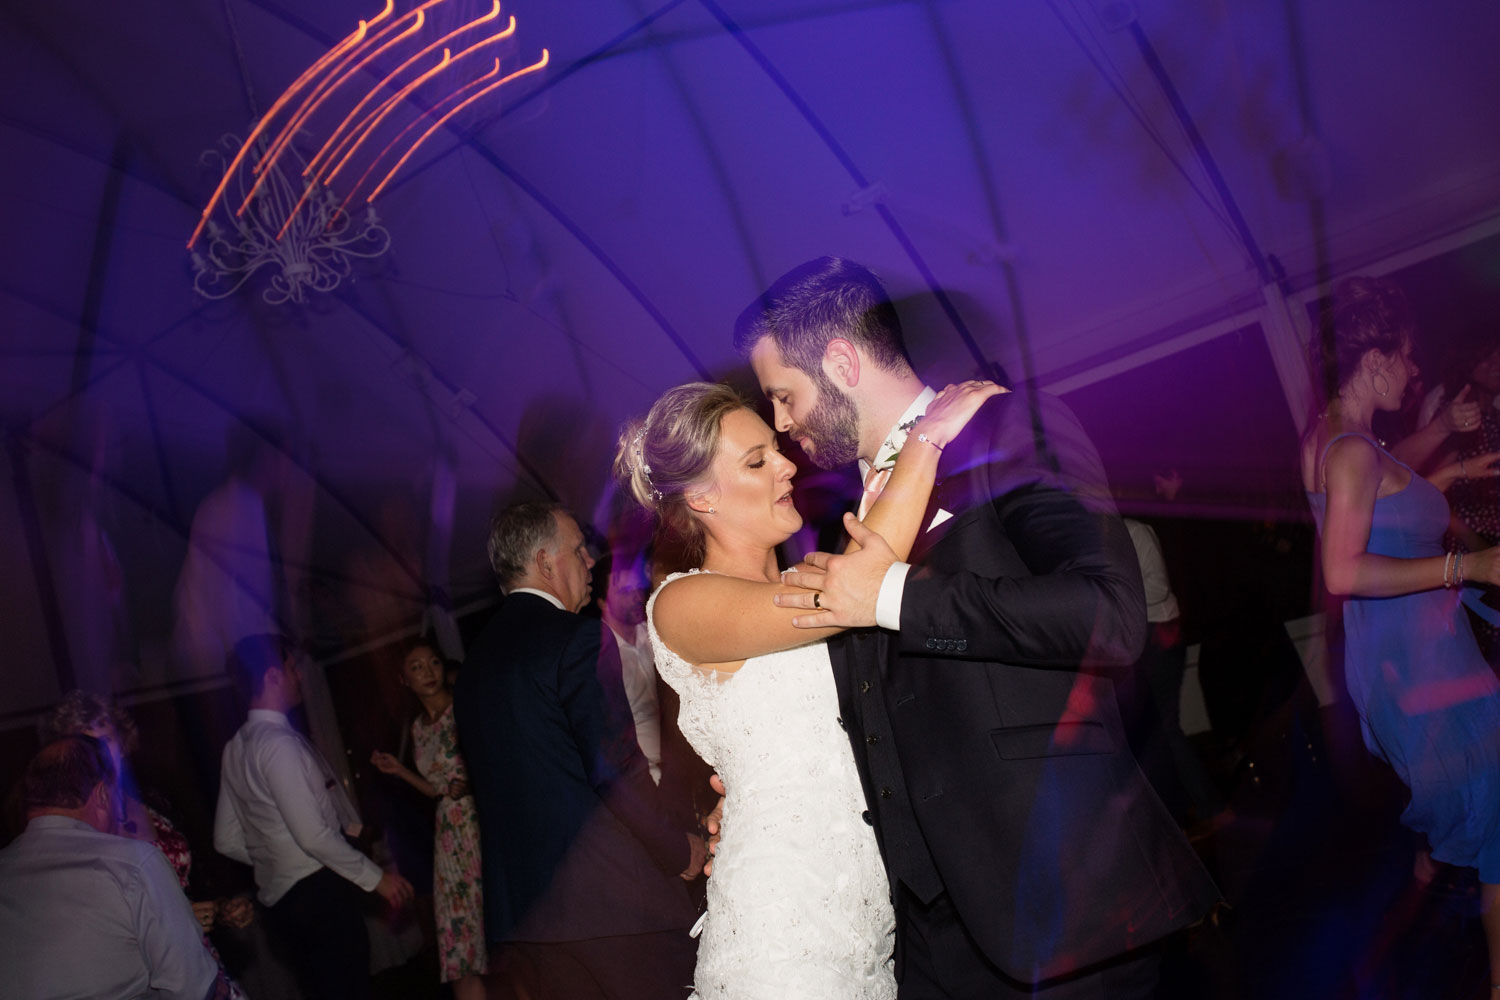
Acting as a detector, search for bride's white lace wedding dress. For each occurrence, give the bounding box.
[647,573,896,1000]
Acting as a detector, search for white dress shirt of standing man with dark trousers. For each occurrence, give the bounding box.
[213,709,381,906]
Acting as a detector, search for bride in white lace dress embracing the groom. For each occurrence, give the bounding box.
[615,382,1001,1000]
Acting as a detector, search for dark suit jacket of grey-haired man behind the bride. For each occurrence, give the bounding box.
[453,594,695,945]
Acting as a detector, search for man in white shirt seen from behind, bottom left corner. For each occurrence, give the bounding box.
[0,735,231,1000]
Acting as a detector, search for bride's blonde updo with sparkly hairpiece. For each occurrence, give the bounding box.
[615,382,750,565]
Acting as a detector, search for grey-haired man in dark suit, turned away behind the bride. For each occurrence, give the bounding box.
[453,504,705,1000]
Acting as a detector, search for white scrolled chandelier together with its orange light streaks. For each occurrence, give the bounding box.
[188,0,548,306]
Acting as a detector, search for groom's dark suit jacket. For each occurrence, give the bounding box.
[833,391,1218,982]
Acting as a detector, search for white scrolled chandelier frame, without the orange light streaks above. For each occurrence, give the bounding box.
[192,135,390,306]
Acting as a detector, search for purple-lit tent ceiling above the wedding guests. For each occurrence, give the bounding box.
[0,0,1500,704]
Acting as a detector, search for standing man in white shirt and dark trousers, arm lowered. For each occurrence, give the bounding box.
[213,634,413,999]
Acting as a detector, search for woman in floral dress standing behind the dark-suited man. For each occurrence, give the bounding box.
[371,643,486,1000]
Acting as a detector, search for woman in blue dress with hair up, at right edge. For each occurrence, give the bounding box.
[1302,277,1500,990]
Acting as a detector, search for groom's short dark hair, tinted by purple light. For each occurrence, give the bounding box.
[735,256,912,378]
